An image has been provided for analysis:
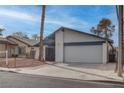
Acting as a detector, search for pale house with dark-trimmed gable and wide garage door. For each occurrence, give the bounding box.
[44,27,112,63]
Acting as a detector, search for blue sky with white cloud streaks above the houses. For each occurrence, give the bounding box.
[0,5,118,45]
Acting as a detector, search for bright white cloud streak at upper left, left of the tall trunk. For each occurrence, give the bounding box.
[0,9,36,21]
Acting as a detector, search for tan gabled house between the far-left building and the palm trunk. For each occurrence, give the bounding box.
[7,36,39,59]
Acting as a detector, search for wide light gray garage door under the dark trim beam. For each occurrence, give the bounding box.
[64,45,102,63]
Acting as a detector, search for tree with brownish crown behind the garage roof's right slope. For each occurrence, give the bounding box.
[91,18,115,62]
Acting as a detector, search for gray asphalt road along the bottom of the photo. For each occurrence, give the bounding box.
[0,71,124,88]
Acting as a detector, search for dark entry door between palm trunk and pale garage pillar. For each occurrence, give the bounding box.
[45,47,55,61]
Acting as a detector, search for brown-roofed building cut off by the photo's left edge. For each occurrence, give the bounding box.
[0,37,17,57]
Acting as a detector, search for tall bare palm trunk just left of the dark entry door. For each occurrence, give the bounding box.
[39,5,46,62]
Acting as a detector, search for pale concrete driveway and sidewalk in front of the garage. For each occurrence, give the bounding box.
[0,62,124,82]
